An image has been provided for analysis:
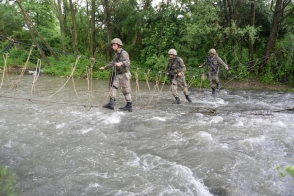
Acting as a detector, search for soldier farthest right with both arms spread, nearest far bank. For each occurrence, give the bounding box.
[199,48,229,95]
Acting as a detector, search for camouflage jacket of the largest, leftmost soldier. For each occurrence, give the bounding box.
[105,48,130,74]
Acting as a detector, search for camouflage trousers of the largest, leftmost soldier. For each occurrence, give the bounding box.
[109,72,132,102]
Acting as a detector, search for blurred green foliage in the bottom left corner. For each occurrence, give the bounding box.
[0,166,19,196]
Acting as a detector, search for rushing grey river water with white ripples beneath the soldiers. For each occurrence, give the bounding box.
[0,76,294,196]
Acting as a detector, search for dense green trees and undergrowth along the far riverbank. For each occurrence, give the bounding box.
[0,0,294,87]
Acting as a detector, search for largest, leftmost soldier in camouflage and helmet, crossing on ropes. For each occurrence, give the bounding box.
[100,38,132,112]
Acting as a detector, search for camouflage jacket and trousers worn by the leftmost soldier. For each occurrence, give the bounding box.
[105,48,132,102]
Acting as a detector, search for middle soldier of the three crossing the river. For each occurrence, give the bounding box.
[166,49,192,104]
